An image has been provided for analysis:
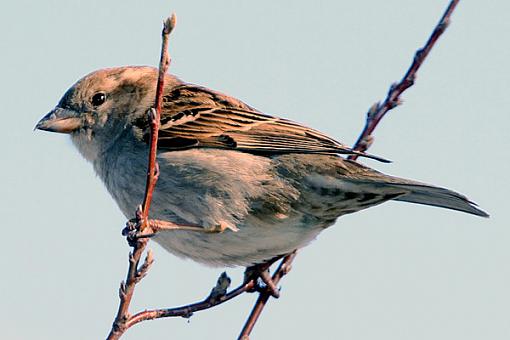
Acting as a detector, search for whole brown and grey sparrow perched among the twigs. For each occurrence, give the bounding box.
[36,67,488,266]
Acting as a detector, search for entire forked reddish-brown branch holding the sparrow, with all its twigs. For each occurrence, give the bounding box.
[108,0,459,340]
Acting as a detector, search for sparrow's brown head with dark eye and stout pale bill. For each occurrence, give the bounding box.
[35,66,177,161]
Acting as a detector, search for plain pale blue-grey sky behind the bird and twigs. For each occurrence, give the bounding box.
[0,0,510,340]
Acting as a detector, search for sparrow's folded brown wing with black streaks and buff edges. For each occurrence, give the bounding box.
[146,85,385,161]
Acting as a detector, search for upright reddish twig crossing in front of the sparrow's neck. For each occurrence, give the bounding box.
[107,15,175,340]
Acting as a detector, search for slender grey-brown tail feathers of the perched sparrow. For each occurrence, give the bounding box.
[388,183,489,217]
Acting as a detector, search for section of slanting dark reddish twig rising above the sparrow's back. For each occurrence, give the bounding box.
[348,0,459,160]
